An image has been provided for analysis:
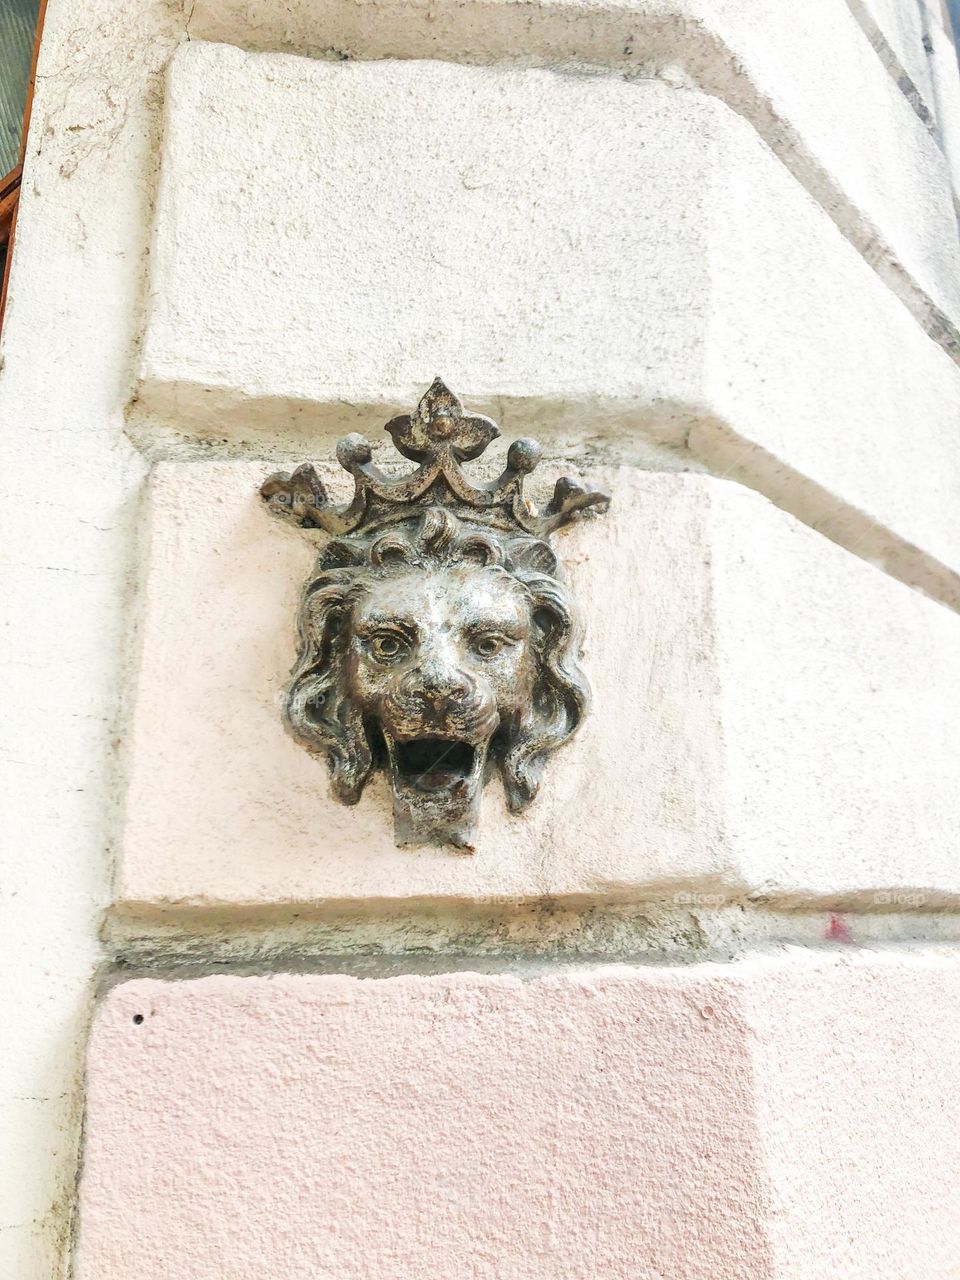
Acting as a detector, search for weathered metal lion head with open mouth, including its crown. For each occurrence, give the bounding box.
[261,379,609,850]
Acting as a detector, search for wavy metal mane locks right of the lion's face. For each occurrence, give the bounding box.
[502,576,590,813]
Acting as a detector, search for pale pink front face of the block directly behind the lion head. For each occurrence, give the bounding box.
[119,463,731,905]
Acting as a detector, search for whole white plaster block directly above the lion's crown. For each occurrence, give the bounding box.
[141,45,960,603]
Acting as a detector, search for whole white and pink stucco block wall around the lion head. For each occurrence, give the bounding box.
[0,0,960,1280]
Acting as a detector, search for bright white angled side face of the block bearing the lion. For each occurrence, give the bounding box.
[708,471,960,909]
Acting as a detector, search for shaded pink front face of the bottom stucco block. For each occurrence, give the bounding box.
[78,974,769,1280]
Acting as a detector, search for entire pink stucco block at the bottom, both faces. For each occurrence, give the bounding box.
[77,952,960,1280]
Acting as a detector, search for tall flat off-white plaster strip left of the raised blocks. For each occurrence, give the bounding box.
[0,0,178,1280]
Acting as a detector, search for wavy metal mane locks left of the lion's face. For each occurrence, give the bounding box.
[284,571,372,804]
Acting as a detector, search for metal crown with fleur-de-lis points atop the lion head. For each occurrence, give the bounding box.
[260,378,609,539]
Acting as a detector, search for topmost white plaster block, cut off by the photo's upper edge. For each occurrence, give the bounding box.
[191,0,960,357]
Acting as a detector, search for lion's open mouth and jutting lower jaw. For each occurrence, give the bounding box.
[384,732,489,852]
